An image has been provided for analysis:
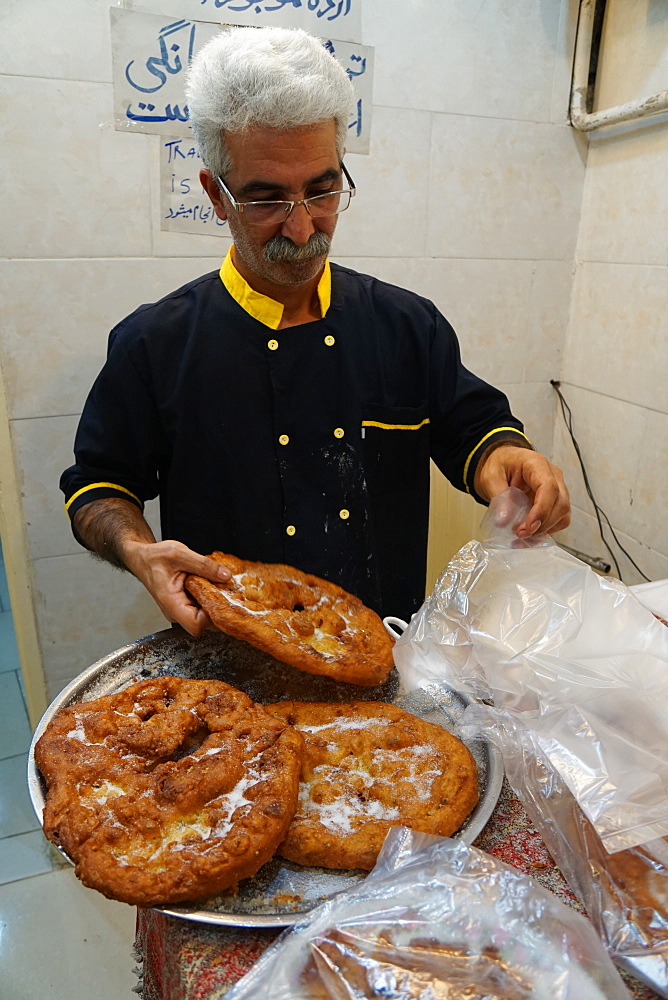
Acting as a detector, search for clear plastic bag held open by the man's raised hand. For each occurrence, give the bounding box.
[388,490,668,852]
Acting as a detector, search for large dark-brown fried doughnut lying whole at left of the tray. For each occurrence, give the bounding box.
[35,677,302,906]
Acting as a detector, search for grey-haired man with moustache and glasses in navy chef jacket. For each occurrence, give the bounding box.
[61,28,569,635]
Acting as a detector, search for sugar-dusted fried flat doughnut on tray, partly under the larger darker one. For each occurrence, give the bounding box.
[266,701,478,869]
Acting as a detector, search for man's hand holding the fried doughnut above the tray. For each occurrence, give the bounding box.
[122,541,232,635]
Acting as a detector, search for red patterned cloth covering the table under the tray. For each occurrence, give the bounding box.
[136,781,660,1000]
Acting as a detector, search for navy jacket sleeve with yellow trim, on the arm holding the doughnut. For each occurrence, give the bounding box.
[60,328,166,519]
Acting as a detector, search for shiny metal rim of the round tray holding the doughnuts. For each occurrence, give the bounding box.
[27,626,505,928]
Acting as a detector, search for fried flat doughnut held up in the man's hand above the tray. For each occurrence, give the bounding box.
[186,552,394,687]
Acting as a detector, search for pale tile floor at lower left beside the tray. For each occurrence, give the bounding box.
[0,555,137,1000]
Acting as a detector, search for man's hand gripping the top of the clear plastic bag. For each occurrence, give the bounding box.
[474,444,571,538]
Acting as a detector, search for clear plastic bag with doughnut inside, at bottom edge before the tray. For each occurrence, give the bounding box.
[228,827,629,1000]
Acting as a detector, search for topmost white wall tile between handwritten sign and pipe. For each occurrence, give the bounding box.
[362,0,563,121]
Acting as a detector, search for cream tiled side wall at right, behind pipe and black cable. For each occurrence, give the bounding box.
[555,0,668,583]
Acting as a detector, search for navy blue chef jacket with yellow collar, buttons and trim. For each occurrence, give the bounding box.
[61,255,526,618]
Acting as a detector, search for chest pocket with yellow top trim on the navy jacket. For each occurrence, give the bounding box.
[361,402,429,494]
